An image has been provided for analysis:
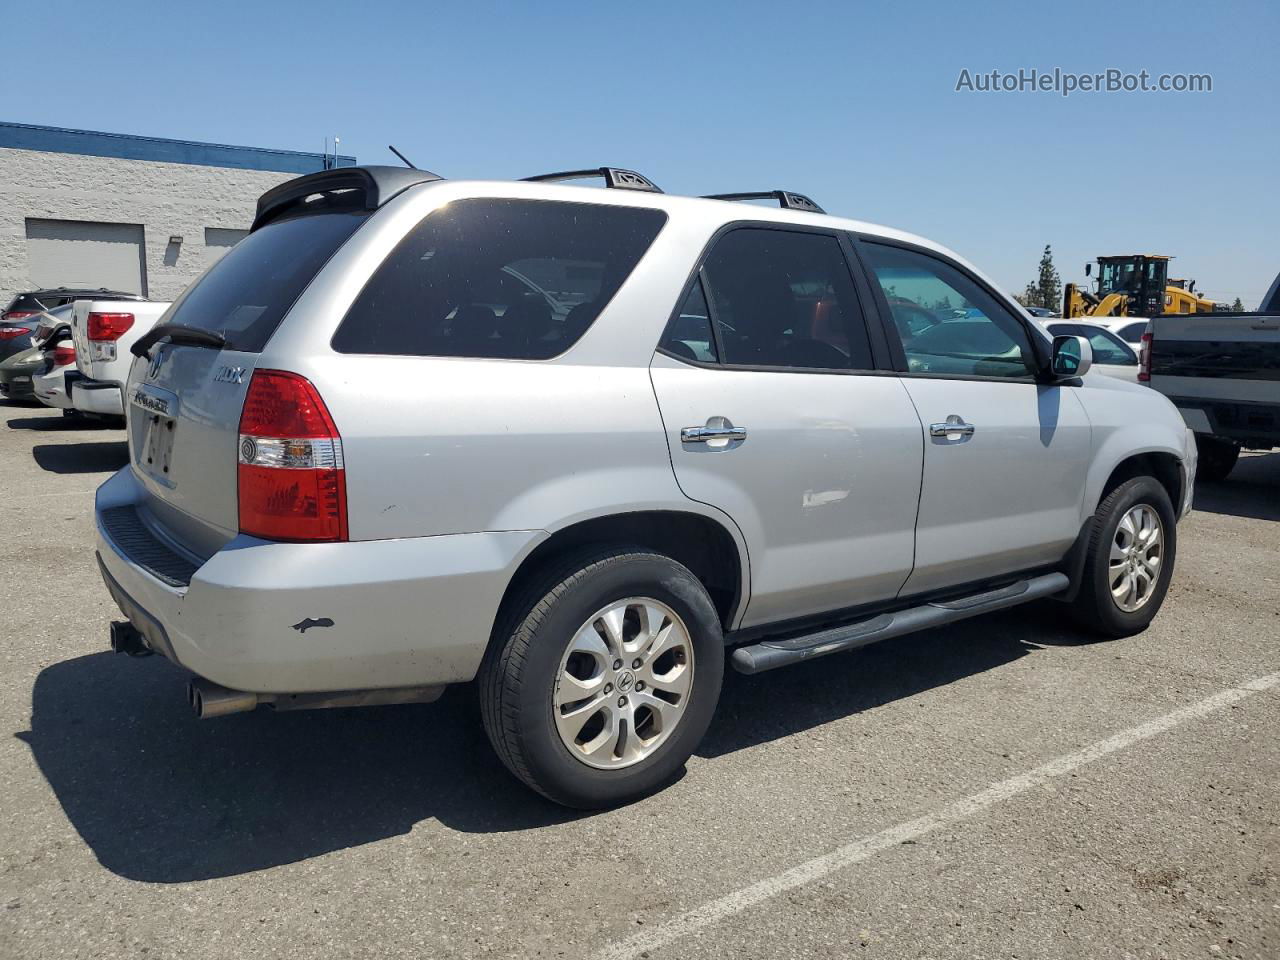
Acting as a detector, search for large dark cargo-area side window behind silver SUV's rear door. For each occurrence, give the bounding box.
[333,198,667,360]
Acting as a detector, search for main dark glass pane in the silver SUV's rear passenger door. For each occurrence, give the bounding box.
[703,229,872,370]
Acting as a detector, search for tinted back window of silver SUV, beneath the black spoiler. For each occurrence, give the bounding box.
[166,212,367,353]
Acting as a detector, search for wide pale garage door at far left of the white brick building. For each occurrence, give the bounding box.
[27,219,147,296]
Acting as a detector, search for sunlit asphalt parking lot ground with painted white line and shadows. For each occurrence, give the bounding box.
[0,406,1280,960]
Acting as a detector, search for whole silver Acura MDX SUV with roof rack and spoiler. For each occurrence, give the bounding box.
[97,168,1196,808]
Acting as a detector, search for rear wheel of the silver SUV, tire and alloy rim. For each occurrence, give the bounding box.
[479,548,724,809]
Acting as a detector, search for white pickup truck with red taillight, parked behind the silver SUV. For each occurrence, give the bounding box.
[72,300,169,416]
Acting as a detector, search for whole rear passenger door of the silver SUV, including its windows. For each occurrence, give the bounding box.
[650,225,923,626]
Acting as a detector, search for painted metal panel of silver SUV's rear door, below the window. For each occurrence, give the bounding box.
[650,355,923,626]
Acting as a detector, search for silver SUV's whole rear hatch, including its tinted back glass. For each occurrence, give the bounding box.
[124,210,367,557]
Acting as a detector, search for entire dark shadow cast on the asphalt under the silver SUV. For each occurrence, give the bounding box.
[17,613,1073,883]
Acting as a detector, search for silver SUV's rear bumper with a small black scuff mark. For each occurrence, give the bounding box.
[97,467,544,694]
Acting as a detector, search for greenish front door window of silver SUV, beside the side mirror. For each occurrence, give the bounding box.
[864,243,1033,376]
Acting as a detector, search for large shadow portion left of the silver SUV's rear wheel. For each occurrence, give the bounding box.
[17,653,576,883]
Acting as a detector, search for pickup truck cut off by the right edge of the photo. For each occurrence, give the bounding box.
[1138,276,1280,480]
